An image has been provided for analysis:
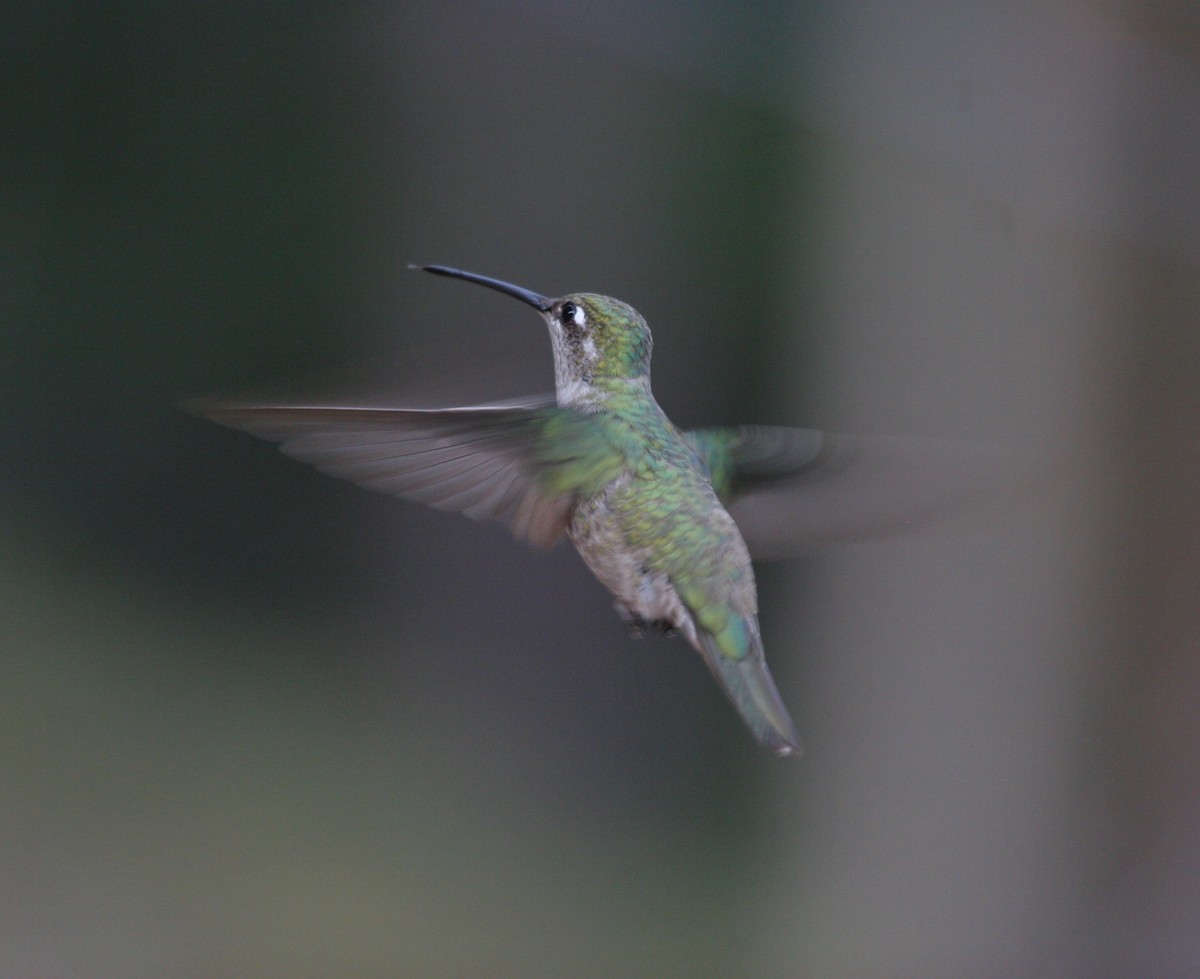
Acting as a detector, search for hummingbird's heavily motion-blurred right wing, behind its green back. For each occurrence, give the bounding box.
[685,426,1030,559]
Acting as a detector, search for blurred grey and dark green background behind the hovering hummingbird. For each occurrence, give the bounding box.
[0,0,1200,979]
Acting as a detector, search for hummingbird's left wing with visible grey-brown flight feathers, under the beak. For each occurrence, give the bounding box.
[192,401,619,547]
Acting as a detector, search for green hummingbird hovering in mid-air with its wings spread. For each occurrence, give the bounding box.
[192,265,1012,756]
